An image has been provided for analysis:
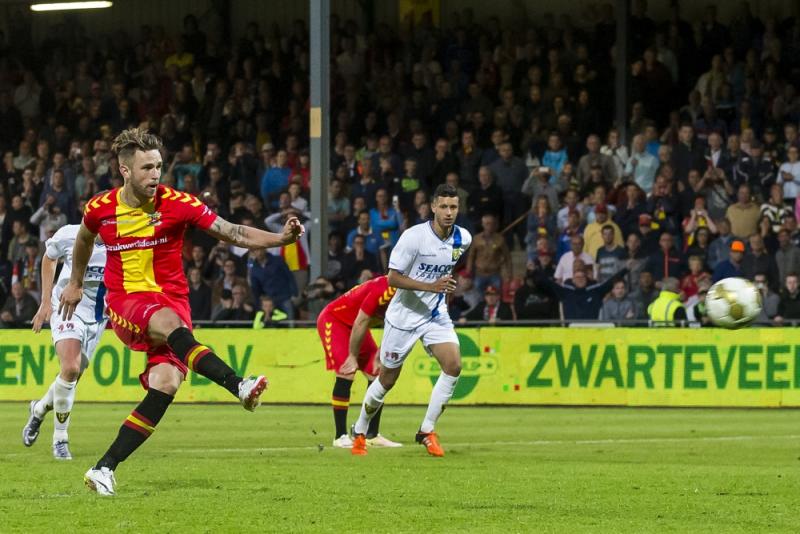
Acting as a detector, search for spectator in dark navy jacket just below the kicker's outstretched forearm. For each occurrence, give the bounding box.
[248,249,298,319]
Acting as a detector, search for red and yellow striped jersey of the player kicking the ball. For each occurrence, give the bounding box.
[83,185,217,297]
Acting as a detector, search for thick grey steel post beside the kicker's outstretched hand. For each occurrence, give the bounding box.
[308,0,331,281]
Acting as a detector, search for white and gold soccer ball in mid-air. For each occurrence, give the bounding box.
[706,278,761,328]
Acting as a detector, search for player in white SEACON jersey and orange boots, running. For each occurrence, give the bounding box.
[351,185,472,456]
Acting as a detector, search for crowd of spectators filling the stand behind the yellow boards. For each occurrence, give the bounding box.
[0,1,800,326]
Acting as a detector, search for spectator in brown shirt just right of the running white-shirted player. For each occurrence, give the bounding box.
[467,215,512,293]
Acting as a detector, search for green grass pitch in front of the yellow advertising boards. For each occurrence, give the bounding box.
[0,404,800,534]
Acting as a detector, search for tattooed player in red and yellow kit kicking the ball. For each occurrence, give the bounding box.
[59,128,304,495]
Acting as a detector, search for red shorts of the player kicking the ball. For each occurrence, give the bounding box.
[106,293,192,389]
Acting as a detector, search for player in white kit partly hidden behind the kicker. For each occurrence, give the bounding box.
[22,224,108,460]
